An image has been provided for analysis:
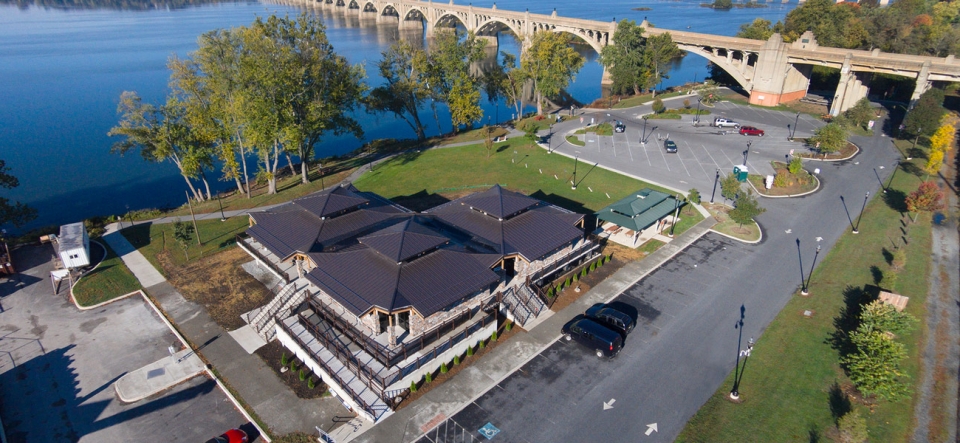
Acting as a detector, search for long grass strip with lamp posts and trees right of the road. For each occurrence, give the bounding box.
[677,160,931,442]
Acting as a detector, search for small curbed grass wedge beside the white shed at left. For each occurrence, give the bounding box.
[73,240,140,306]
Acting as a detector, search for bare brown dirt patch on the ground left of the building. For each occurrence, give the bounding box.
[158,247,273,330]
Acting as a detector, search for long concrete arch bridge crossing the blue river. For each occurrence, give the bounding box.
[288,0,960,115]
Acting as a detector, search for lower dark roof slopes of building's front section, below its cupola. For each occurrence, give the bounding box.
[307,245,500,317]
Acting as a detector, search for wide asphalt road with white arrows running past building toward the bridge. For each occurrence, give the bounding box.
[419,102,898,443]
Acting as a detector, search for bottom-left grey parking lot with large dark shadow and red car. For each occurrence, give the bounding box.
[0,245,246,443]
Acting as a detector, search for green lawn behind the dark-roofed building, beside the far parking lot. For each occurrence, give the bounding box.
[354,139,703,234]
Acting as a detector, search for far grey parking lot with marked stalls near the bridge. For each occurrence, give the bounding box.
[551,97,823,195]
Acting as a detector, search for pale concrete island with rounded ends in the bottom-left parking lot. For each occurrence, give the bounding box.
[114,349,204,403]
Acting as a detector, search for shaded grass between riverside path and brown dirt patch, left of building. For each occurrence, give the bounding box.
[121,217,249,277]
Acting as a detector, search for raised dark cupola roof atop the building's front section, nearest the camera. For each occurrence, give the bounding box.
[357,218,450,262]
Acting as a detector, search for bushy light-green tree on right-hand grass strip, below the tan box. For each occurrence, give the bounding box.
[840,325,910,401]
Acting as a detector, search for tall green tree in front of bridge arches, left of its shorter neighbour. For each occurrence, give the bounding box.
[600,19,651,95]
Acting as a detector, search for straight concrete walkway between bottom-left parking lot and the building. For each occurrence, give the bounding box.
[103,225,353,435]
